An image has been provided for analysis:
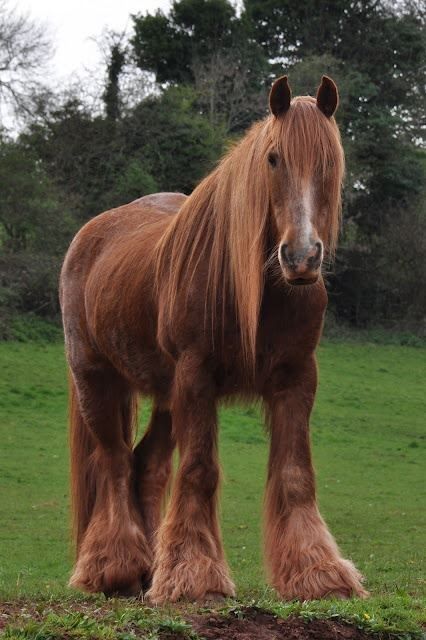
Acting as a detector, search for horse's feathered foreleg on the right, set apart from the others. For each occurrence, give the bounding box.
[265,358,366,600]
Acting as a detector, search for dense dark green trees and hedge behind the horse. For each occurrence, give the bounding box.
[0,0,426,335]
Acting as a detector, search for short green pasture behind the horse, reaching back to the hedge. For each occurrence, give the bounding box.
[0,342,426,628]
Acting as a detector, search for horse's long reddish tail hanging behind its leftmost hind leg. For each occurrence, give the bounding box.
[69,375,137,552]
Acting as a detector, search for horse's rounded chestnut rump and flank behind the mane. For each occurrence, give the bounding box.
[60,193,185,384]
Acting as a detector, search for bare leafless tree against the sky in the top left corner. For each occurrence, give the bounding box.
[0,0,52,122]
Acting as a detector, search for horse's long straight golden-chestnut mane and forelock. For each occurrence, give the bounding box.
[156,97,344,366]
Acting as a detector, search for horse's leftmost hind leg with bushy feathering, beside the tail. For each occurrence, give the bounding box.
[70,367,152,595]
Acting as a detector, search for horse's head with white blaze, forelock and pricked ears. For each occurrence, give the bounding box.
[265,76,344,285]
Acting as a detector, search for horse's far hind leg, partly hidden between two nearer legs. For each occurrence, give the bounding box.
[134,406,175,546]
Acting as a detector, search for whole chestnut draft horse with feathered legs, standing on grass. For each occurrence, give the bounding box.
[60,76,366,603]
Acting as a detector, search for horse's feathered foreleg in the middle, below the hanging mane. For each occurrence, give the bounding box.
[148,353,234,604]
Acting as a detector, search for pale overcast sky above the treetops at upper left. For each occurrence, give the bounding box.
[15,0,170,80]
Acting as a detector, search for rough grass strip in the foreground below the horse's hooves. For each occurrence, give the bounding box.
[0,592,426,640]
